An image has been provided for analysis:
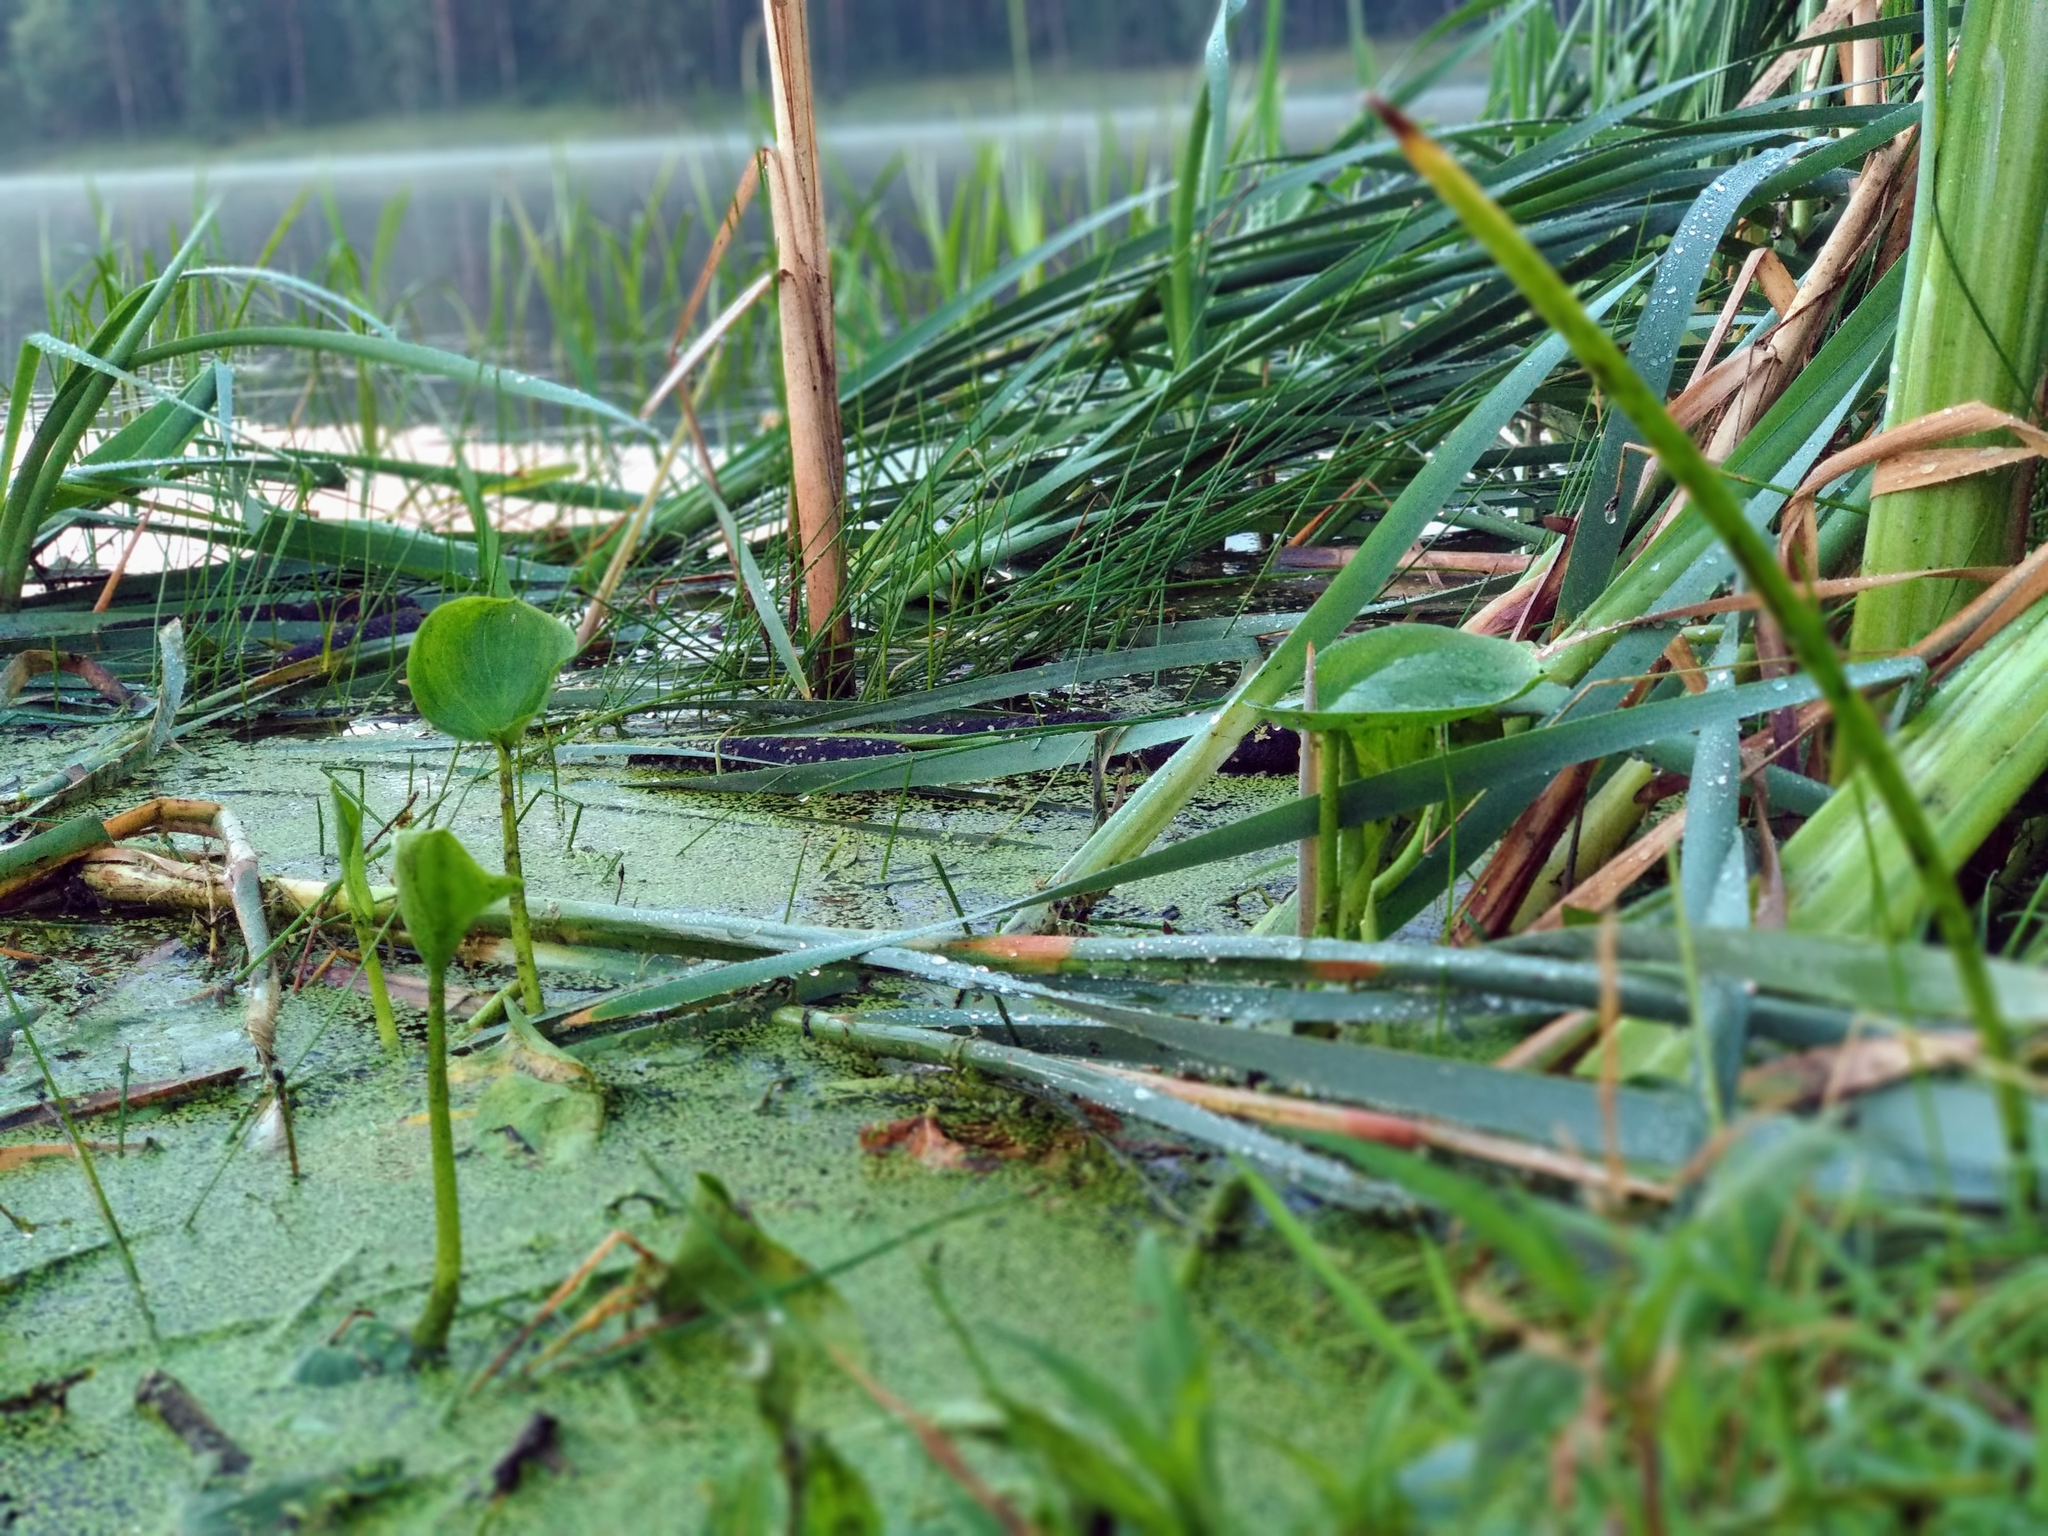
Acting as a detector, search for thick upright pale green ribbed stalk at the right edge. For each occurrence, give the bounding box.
[1849,0,2048,653]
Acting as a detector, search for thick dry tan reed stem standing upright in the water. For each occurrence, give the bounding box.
[762,0,854,698]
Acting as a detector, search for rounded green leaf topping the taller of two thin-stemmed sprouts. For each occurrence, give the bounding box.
[406,598,575,745]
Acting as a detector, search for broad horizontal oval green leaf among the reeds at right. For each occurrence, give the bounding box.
[1260,625,1542,731]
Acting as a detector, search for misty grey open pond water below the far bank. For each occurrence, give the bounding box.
[0,84,1485,356]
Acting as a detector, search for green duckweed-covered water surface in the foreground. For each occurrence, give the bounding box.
[0,723,1360,1532]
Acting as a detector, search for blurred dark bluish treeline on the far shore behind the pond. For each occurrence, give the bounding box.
[0,0,1450,141]
